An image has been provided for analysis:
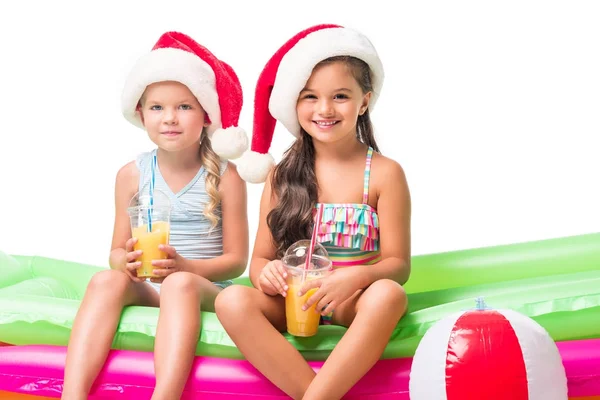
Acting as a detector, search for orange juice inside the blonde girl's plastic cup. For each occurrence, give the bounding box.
[131,221,169,278]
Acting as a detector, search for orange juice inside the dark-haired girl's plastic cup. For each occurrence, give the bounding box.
[285,284,321,337]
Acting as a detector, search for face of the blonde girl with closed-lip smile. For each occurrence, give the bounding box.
[140,81,207,151]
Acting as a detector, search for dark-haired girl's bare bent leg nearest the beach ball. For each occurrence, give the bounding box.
[304,279,407,400]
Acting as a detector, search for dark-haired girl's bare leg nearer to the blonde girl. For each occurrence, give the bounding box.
[215,285,315,399]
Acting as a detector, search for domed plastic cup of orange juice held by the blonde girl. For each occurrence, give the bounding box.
[127,190,171,278]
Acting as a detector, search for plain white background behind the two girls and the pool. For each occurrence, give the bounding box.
[0,0,600,276]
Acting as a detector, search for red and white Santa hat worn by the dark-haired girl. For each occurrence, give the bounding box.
[237,24,384,183]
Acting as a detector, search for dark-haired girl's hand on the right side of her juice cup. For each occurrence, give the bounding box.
[298,266,365,315]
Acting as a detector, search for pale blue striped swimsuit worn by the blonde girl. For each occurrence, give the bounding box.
[136,149,232,291]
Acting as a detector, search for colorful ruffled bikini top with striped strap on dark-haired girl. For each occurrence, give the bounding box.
[315,147,381,268]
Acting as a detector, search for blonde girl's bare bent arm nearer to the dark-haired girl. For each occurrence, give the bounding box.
[176,163,248,281]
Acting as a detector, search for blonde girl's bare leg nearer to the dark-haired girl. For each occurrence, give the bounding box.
[152,272,220,400]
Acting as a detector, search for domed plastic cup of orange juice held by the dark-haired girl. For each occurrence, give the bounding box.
[281,240,331,337]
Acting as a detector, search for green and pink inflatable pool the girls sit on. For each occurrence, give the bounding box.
[0,234,600,399]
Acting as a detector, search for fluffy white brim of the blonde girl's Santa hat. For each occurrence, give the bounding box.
[121,48,221,134]
